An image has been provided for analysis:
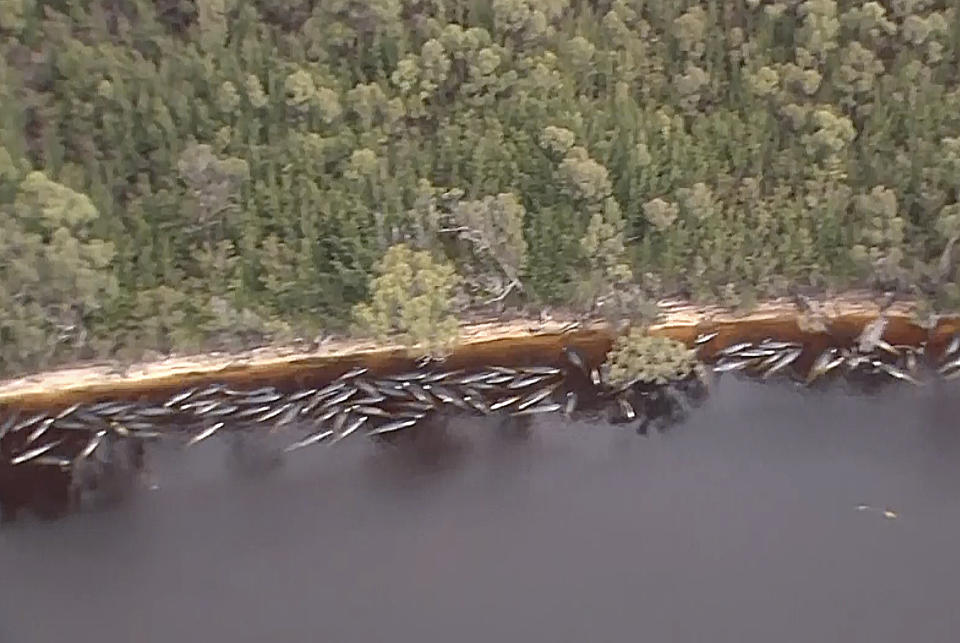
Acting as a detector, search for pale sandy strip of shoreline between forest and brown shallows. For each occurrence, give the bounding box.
[0,293,944,406]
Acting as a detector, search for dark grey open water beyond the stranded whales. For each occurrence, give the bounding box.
[0,377,960,643]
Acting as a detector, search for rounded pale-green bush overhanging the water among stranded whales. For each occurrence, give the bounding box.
[604,327,697,386]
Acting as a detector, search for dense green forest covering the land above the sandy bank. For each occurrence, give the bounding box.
[0,0,960,374]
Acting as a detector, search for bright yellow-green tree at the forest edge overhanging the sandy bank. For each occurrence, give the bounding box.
[354,244,458,355]
